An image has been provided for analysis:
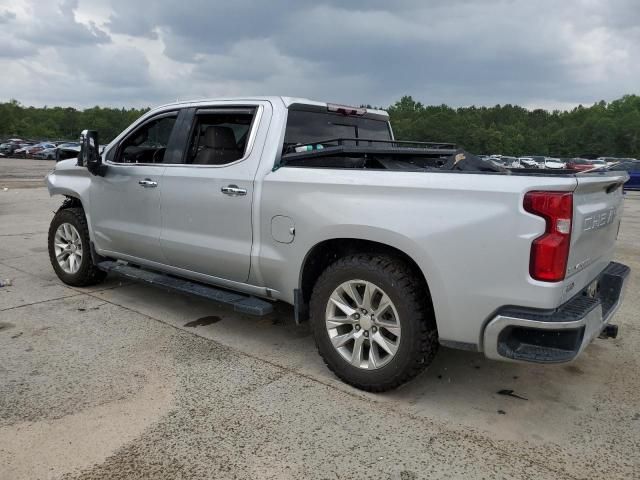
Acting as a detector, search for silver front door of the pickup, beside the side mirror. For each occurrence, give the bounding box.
[90,111,182,263]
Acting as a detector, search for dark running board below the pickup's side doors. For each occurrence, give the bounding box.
[97,260,273,316]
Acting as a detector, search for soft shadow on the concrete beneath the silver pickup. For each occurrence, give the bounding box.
[97,284,630,442]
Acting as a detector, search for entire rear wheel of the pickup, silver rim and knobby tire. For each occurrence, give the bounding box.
[311,254,438,392]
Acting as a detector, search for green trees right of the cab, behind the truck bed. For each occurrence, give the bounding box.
[388,95,640,158]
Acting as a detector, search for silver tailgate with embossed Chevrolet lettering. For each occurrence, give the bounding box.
[567,172,628,280]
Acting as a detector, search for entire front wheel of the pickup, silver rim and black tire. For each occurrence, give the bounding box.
[48,208,106,287]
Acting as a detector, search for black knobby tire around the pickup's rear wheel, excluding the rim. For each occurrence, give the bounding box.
[310,254,439,392]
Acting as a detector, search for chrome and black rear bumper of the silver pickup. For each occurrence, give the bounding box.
[484,262,630,363]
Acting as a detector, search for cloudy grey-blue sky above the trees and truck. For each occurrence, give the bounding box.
[0,0,640,109]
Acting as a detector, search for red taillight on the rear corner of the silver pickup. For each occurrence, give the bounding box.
[524,192,573,282]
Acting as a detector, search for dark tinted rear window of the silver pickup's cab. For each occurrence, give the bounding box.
[284,110,391,146]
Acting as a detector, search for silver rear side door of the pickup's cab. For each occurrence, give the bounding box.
[160,102,271,282]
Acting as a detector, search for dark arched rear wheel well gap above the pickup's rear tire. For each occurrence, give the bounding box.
[300,238,433,317]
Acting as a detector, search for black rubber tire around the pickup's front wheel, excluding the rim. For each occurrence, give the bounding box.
[48,208,107,287]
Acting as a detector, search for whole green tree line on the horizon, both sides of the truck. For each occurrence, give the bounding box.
[0,95,640,158]
